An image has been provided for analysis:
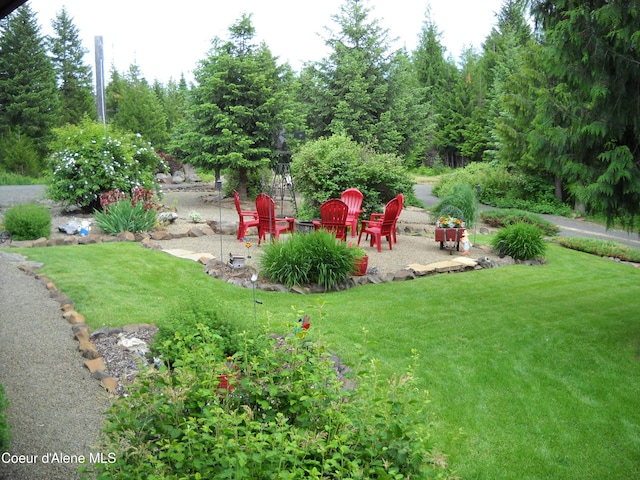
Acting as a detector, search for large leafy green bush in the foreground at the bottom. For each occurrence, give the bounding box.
[95,318,447,480]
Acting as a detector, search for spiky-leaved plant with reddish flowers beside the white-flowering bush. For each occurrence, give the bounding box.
[94,188,157,235]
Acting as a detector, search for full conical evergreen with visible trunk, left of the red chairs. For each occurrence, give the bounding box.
[179,15,291,198]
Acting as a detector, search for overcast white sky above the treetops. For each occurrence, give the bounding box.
[28,0,502,84]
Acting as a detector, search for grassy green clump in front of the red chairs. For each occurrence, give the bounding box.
[260,231,358,289]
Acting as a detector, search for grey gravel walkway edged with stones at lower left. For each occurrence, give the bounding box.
[0,252,110,480]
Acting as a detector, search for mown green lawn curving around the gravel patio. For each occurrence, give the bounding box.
[5,243,640,480]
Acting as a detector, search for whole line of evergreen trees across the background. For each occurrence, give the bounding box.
[0,0,640,226]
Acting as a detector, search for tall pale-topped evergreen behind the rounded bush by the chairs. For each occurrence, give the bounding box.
[301,0,406,153]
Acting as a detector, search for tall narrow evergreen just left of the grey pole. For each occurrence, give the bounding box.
[49,7,96,125]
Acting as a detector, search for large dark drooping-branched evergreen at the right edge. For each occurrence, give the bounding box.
[532,0,640,228]
